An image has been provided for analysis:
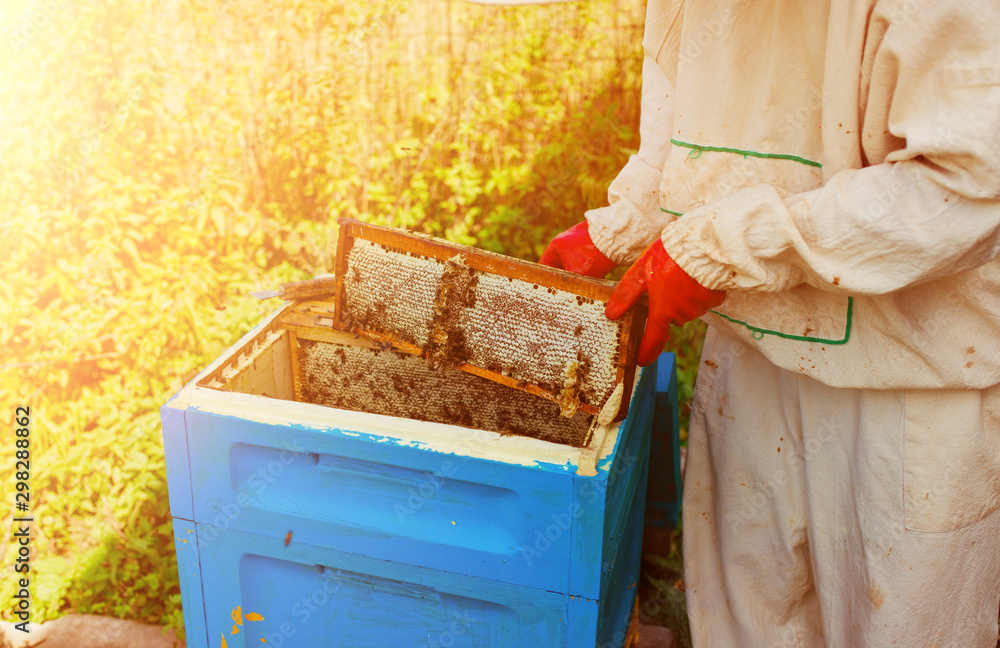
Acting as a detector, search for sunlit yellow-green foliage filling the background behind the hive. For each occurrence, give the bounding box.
[0,0,700,627]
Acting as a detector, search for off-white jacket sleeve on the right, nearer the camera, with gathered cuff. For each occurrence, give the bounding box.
[661,0,1000,295]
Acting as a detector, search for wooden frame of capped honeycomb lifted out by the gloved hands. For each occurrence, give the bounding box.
[332,219,645,419]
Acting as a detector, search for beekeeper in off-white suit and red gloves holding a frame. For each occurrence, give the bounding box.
[543,0,1000,648]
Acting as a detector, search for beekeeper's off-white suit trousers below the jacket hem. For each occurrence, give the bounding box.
[683,328,1000,648]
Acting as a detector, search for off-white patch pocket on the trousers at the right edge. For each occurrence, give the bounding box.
[903,386,1000,532]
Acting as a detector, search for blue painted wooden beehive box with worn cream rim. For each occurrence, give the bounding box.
[162,304,655,646]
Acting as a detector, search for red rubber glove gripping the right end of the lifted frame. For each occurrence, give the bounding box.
[604,240,726,367]
